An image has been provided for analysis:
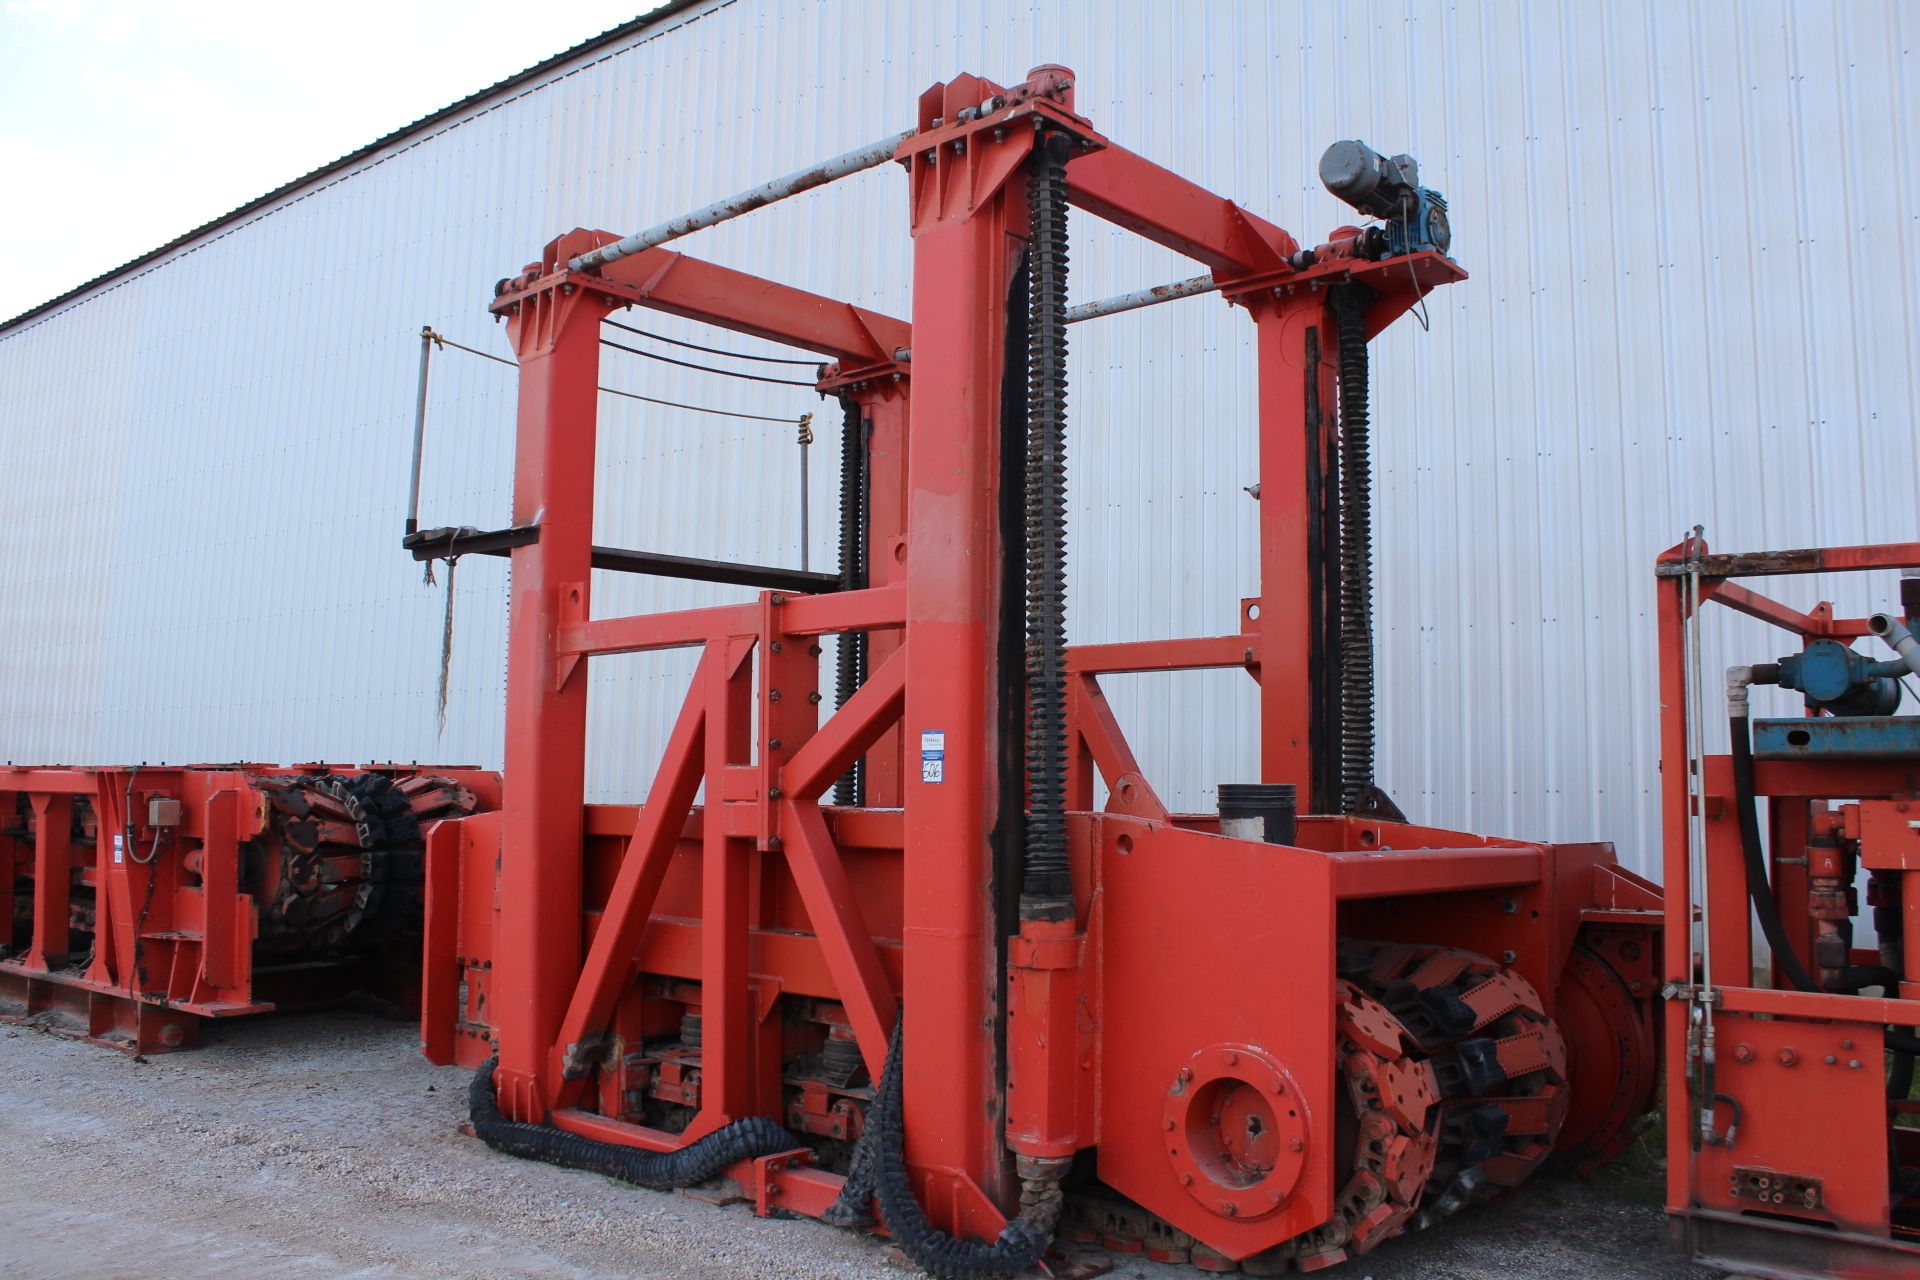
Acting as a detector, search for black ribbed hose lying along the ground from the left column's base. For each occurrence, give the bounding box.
[467,1057,806,1192]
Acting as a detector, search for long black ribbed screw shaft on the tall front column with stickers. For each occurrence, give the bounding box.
[1021,134,1073,917]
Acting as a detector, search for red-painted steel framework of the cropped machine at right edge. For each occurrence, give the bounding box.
[1657,543,1920,1278]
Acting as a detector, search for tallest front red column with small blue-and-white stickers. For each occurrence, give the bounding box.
[898,77,1031,1236]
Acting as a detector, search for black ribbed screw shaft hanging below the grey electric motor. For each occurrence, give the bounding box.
[1329,284,1375,814]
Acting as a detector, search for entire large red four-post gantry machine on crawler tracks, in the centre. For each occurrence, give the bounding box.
[407,67,1661,1276]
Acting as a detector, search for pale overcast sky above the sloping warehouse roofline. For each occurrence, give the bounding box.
[0,0,655,319]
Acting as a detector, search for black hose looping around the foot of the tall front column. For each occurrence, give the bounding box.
[822,1015,1064,1280]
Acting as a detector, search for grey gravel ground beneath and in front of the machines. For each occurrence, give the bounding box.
[0,1013,1713,1280]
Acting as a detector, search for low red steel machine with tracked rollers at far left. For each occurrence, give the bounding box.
[0,764,499,1054]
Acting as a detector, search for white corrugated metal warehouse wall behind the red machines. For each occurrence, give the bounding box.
[0,0,1920,890]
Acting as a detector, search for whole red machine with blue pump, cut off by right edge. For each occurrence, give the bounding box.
[1657,530,1920,1278]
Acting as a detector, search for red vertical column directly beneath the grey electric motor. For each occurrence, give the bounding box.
[1248,288,1338,804]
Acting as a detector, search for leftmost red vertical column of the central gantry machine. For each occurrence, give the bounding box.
[493,262,607,1121]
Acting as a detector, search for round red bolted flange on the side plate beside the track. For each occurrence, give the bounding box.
[1162,1044,1309,1221]
